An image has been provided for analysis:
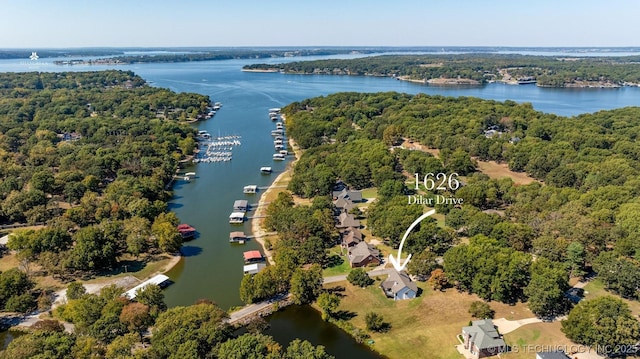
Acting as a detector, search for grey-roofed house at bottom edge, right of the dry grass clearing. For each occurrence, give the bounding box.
[462,319,507,358]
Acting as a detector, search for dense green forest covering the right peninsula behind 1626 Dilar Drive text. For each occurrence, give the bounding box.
[280,93,640,352]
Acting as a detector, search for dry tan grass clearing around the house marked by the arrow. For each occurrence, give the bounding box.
[327,278,531,359]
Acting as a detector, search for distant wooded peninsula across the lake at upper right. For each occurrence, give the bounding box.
[244,54,640,87]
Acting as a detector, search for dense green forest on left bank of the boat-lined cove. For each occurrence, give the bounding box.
[0,71,210,292]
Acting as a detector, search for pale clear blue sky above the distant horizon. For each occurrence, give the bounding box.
[0,0,640,48]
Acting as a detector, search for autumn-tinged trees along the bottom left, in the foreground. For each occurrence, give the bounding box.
[0,282,333,359]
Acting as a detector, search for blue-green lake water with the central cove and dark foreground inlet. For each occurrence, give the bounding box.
[0,55,640,358]
